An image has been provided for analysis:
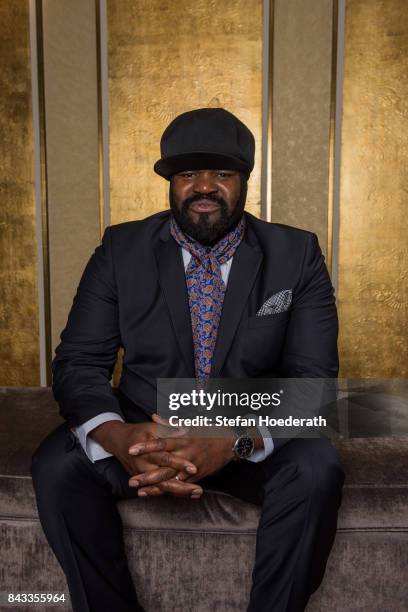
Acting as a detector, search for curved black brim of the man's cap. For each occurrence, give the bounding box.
[153,151,251,180]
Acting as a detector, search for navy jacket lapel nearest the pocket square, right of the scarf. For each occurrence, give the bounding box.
[211,217,263,378]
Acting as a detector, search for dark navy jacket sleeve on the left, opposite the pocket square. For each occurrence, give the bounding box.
[51,227,124,427]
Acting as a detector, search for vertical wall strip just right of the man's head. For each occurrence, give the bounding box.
[261,0,275,221]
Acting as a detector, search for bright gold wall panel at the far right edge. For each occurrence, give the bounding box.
[339,0,408,378]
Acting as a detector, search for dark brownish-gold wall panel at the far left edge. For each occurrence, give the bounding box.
[0,0,40,386]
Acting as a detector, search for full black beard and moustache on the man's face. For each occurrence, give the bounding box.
[169,173,247,246]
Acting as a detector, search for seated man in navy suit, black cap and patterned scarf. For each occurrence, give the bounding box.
[32,108,344,612]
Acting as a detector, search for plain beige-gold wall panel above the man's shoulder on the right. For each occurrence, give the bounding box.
[271,0,333,253]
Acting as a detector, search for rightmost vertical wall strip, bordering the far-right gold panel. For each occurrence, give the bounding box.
[330,0,346,294]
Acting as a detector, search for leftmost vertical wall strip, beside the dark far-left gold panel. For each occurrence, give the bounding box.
[29,0,52,387]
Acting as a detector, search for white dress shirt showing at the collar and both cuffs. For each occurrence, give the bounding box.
[73,247,274,463]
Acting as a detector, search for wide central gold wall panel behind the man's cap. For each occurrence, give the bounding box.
[107,0,262,223]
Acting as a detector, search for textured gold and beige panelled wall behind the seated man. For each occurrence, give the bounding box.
[0,0,408,386]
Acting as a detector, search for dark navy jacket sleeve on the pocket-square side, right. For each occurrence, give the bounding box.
[274,233,339,451]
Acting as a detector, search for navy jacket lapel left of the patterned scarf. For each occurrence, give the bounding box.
[156,224,195,378]
